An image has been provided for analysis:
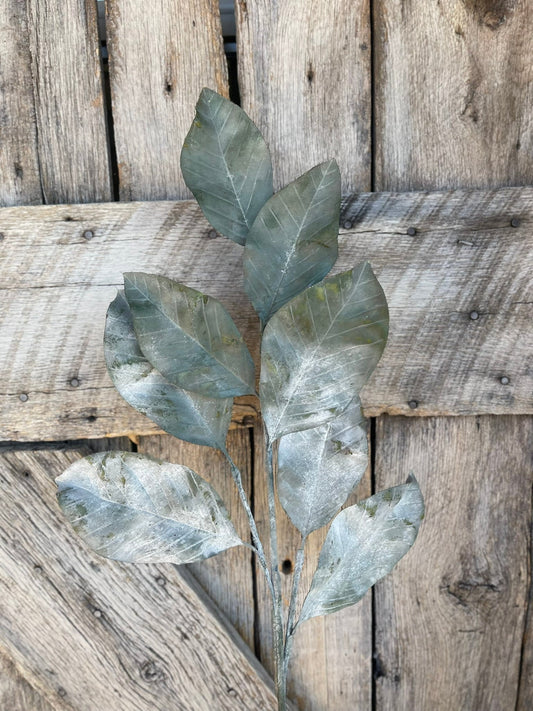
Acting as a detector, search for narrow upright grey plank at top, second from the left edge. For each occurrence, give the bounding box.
[25,0,111,203]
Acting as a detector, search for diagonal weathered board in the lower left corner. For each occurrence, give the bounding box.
[0,450,275,711]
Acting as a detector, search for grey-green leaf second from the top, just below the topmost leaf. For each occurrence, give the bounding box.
[243,160,341,323]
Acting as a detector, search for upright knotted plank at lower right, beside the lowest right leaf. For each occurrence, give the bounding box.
[375,417,533,711]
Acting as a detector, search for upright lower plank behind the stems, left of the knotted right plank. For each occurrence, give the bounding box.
[254,425,372,711]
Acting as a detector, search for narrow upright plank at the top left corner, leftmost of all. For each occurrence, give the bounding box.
[0,0,41,205]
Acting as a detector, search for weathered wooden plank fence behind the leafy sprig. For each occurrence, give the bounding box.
[0,0,533,711]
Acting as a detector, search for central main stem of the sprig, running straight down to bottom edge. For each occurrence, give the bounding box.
[265,434,287,711]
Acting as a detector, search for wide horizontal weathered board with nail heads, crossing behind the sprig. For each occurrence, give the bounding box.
[0,188,533,440]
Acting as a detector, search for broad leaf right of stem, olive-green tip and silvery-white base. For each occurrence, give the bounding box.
[260,262,389,440]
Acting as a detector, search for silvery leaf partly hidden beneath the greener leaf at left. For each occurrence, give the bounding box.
[104,292,233,450]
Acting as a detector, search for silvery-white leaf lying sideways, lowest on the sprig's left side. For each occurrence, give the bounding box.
[56,452,242,564]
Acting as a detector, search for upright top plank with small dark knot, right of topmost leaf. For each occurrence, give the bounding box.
[235,0,372,192]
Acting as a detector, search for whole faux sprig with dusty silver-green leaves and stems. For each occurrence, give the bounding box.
[57,89,424,709]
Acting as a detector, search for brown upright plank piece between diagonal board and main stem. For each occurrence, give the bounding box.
[138,427,254,649]
